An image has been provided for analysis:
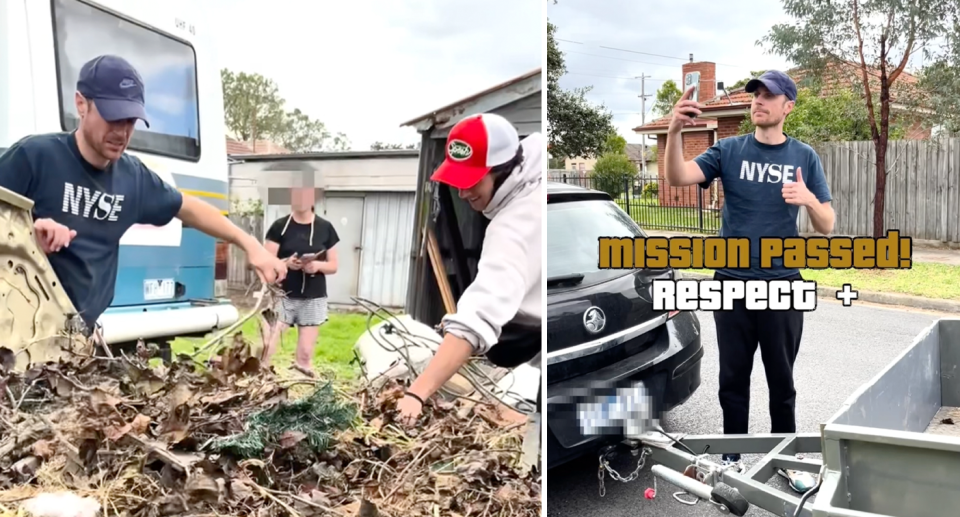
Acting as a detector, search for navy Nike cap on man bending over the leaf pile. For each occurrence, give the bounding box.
[77,55,150,127]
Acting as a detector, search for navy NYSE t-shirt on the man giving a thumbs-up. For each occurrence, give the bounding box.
[694,133,831,280]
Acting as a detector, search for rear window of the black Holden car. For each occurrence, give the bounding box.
[547,200,646,278]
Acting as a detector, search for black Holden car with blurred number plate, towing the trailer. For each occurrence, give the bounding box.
[546,183,703,470]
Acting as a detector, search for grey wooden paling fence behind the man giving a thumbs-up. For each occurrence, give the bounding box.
[800,138,960,243]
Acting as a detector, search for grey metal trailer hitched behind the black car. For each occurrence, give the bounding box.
[599,318,960,517]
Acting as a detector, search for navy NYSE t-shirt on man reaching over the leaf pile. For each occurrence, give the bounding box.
[0,133,183,328]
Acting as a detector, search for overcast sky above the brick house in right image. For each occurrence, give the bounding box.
[548,0,790,143]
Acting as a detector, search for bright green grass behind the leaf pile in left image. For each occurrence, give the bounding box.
[173,312,380,380]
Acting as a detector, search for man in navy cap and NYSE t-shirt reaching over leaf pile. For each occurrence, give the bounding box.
[0,55,287,335]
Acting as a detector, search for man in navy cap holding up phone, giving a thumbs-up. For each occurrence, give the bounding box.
[664,71,835,476]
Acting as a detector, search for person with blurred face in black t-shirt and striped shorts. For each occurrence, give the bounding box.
[262,188,340,377]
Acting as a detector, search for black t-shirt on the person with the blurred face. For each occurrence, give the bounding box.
[267,215,340,299]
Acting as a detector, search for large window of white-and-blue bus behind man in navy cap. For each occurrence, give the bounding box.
[53,0,200,161]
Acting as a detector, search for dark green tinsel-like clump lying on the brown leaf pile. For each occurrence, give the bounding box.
[212,383,356,459]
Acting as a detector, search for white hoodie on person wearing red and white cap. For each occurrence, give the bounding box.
[443,133,545,354]
